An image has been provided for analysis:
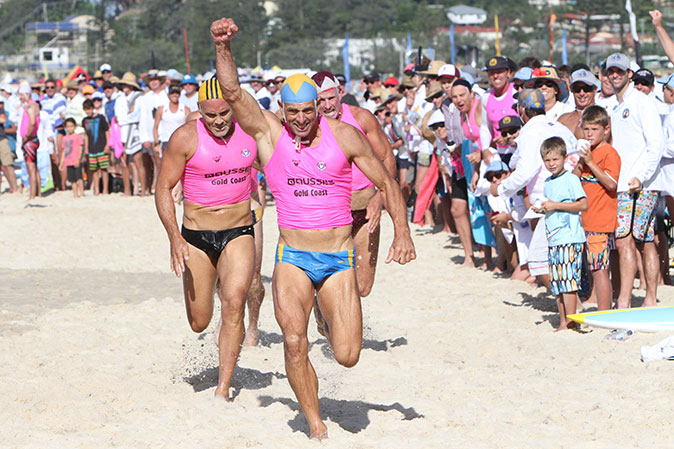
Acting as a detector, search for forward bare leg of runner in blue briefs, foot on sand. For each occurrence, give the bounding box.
[272,263,326,439]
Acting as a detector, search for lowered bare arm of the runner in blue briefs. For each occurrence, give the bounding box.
[336,120,416,264]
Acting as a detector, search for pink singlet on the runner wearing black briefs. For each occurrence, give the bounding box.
[181,119,257,207]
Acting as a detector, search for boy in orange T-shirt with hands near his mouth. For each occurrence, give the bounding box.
[574,106,620,310]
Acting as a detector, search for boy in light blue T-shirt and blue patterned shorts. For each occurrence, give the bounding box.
[534,137,587,331]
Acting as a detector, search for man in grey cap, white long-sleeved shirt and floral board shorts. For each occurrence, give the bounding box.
[606,53,666,308]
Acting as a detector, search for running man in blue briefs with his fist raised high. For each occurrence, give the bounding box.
[211,18,416,439]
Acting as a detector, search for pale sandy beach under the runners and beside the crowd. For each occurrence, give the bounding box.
[0,192,674,449]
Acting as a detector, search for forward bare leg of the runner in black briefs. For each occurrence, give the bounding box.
[215,235,255,400]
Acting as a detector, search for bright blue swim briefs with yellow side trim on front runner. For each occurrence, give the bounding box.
[276,243,355,286]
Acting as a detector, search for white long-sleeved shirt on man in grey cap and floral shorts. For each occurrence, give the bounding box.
[608,86,664,192]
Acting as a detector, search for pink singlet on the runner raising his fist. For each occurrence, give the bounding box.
[264,117,353,229]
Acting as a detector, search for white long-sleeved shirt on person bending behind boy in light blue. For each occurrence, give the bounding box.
[498,115,577,204]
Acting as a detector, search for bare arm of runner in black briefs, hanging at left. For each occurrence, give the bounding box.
[154,123,196,277]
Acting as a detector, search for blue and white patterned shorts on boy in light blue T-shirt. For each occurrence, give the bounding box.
[539,243,585,296]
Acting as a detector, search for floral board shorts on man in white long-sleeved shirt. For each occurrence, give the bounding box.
[615,190,660,242]
